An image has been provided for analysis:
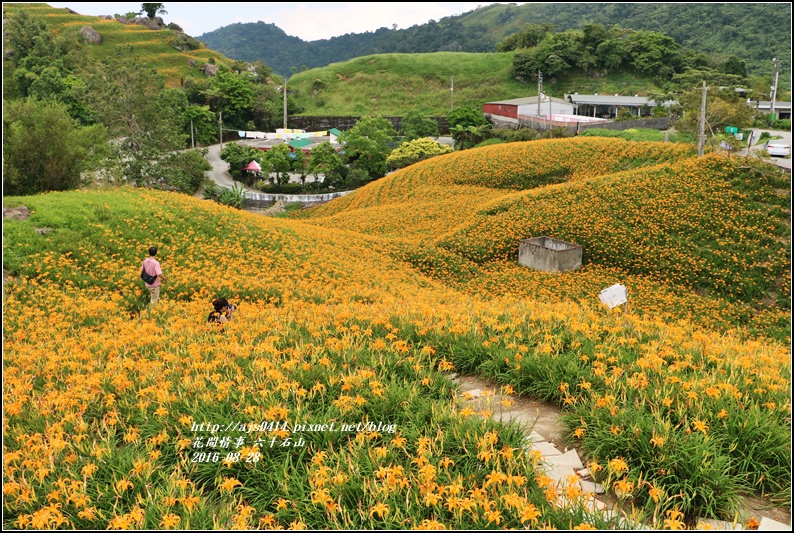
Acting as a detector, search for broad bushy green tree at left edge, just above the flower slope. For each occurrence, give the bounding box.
[3,98,110,195]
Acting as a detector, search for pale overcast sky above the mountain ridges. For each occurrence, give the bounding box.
[47,2,526,41]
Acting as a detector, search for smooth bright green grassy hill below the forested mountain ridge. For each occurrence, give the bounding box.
[289,52,668,116]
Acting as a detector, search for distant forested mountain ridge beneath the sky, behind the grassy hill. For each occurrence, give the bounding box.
[198,3,791,80]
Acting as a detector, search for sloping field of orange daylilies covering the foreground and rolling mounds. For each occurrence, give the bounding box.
[3,139,791,529]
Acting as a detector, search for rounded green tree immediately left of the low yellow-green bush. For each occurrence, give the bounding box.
[340,117,397,180]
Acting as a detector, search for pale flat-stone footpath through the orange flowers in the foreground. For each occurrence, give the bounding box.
[449,374,792,531]
